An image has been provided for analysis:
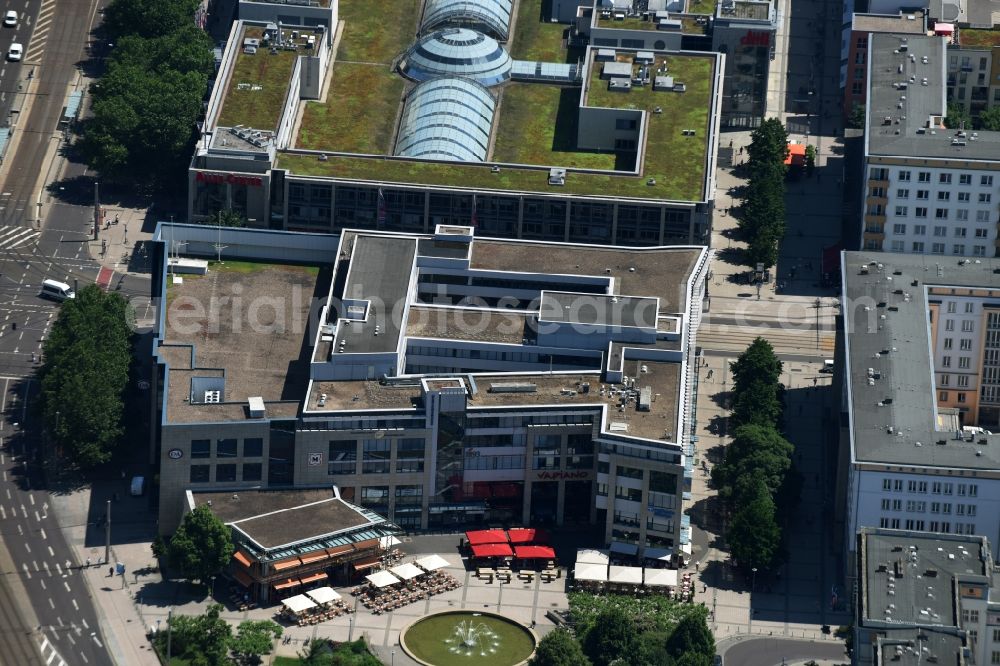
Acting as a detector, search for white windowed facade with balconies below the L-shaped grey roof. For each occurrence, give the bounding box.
[865,162,1000,257]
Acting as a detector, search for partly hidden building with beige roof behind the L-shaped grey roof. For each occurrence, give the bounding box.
[840,9,927,118]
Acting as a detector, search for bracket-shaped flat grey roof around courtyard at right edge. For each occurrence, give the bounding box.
[843,252,1000,469]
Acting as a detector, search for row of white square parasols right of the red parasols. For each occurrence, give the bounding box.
[572,550,694,602]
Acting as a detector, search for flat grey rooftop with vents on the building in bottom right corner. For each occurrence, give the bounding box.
[859,529,992,632]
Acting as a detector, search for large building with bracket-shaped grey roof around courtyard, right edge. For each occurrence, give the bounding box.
[837,252,1000,572]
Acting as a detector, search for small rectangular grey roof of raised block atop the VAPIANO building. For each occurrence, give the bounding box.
[539,291,657,328]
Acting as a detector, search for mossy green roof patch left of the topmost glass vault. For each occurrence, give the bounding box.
[337,0,420,64]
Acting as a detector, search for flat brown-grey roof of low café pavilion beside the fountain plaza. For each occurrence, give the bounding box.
[194,488,371,549]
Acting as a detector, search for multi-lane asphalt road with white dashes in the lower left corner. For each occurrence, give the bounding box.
[0,377,114,666]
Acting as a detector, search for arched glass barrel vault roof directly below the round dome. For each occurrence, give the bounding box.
[395,78,496,162]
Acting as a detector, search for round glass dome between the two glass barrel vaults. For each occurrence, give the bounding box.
[399,28,511,86]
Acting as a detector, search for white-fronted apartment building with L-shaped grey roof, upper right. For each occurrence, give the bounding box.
[861,34,1000,257]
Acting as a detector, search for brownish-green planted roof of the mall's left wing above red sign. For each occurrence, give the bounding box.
[218,28,300,130]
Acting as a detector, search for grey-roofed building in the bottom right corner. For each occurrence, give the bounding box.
[852,528,1000,665]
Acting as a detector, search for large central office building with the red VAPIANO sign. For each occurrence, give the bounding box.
[155,224,708,557]
